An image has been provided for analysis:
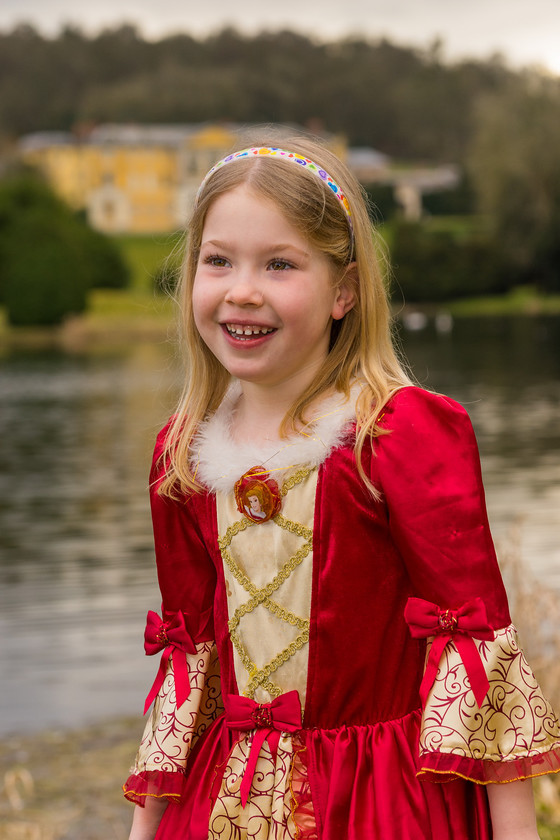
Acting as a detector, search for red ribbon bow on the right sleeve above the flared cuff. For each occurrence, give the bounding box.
[404,598,494,707]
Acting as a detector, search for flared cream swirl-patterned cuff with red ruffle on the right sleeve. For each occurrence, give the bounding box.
[419,626,560,783]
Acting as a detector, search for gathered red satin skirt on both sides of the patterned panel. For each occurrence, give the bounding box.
[148,710,491,840]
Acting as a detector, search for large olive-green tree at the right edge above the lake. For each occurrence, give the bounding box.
[470,74,560,291]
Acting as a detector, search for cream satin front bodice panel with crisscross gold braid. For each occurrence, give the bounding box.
[216,468,317,707]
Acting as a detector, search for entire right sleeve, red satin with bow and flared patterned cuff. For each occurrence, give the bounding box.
[372,387,560,784]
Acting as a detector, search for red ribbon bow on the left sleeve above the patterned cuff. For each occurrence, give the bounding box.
[144,610,196,714]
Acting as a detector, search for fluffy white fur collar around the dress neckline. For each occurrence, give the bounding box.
[192,383,359,493]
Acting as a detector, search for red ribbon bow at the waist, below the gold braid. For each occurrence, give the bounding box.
[226,691,301,807]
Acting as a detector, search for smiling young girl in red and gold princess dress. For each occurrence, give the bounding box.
[125,138,560,840]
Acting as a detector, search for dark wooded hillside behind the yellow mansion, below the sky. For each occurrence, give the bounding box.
[0,25,517,163]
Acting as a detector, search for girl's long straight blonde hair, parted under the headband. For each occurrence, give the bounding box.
[159,135,411,498]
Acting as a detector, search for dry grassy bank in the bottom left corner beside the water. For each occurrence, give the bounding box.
[0,716,144,840]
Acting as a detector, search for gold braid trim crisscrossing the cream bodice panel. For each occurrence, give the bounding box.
[218,467,313,697]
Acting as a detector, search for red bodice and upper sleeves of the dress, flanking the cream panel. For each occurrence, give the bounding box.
[152,388,510,729]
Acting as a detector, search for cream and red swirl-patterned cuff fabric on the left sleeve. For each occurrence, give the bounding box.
[132,642,223,774]
